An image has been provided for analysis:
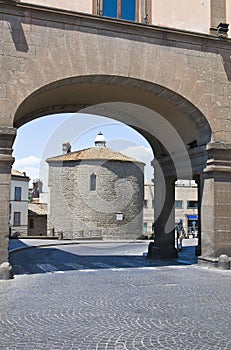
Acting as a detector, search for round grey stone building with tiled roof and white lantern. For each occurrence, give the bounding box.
[47,132,144,239]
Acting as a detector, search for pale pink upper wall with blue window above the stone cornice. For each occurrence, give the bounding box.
[20,0,231,37]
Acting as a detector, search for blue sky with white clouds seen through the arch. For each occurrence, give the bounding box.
[13,113,153,191]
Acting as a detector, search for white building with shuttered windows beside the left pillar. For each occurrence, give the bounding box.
[10,169,30,237]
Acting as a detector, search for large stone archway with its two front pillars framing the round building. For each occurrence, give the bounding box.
[0,2,231,278]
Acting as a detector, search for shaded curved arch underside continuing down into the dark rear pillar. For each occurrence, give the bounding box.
[11,75,211,257]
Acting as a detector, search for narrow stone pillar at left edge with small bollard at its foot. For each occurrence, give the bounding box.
[0,127,16,279]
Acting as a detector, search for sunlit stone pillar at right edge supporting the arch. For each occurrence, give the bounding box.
[200,143,231,261]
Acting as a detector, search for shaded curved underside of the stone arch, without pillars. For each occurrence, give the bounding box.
[14,75,211,171]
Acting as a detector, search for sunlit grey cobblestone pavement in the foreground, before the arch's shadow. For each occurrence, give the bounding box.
[0,265,231,350]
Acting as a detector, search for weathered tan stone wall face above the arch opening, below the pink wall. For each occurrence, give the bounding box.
[0,4,231,142]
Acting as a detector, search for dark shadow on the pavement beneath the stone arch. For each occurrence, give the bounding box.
[9,247,197,275]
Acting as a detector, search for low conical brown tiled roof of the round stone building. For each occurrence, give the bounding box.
[47,147,144,164]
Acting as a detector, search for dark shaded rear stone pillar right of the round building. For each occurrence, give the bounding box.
[148,162,177,258]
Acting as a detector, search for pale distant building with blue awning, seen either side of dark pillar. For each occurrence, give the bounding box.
[143,180,198,237]
